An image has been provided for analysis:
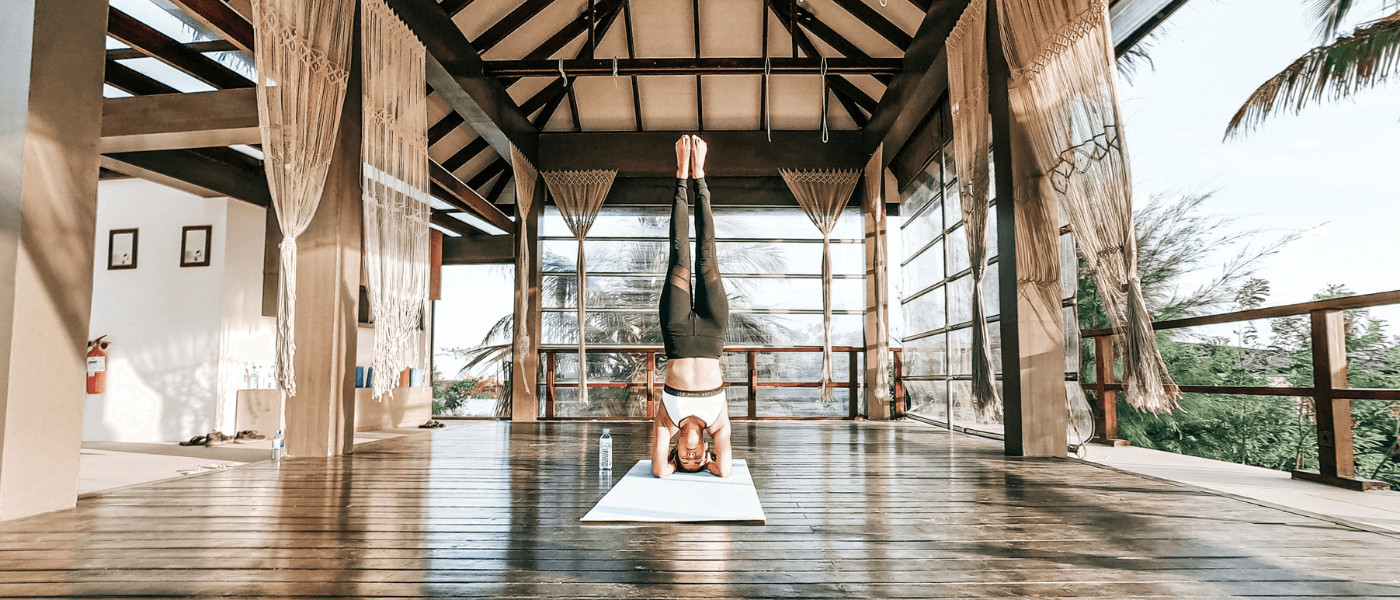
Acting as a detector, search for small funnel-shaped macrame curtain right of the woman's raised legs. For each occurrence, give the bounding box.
[778,169,861,403]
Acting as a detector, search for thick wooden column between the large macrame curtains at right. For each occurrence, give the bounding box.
[987,1,1068,456]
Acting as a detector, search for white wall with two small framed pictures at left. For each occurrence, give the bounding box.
[83,179,273,442]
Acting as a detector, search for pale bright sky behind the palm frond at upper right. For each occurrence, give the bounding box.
[1119,0,1400,334]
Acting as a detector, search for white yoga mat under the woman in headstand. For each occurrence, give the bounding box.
[580,459,766,524]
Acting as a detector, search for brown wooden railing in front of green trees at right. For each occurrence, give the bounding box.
[1067,291,1400,490]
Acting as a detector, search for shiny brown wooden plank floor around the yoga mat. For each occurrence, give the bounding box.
[0,422,1400,599]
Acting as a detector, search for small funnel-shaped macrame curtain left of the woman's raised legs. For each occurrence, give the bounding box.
[540,169,617,404]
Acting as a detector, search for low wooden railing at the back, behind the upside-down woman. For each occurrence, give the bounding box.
[540,345,865,420]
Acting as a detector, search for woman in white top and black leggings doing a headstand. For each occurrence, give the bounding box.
[651,136,734,477]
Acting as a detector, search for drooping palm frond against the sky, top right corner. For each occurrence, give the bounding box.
[1225,0,1400,138]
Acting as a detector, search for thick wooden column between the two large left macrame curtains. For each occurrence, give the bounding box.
[286,20,361,456]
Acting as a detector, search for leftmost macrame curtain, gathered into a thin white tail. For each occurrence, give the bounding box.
[253,0,354,396]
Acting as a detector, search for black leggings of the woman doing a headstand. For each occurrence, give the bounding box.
[661,178,729,358]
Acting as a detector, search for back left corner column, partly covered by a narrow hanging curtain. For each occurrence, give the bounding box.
[511,185,545,422]
